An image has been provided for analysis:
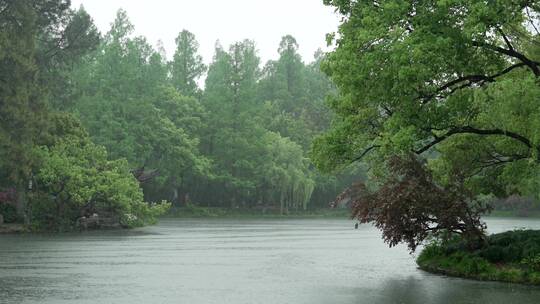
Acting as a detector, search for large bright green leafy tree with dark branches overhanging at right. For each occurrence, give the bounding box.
[313,0,540,195]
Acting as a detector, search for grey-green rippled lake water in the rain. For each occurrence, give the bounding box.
[0,218,540,304]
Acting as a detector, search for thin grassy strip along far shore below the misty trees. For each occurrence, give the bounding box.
[164,205,350,218]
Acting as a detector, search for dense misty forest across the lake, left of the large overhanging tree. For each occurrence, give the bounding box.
[0,0,361,227]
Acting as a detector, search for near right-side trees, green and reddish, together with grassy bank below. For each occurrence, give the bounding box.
[311,0,540,283]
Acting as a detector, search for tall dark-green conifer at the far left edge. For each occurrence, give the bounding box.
[0,1,46,197]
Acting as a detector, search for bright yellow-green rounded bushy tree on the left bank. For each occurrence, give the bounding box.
[35,116,168,230]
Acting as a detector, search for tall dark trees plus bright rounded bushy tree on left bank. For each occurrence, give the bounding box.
[0,0,167,229]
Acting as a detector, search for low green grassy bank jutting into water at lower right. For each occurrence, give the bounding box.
[416,230,540,285]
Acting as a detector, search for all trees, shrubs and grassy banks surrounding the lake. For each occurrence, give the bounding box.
[0,0,540,290]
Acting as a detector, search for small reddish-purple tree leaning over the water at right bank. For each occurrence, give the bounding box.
[337,156,489,251]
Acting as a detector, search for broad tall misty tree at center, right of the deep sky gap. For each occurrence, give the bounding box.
[203,40,265,206]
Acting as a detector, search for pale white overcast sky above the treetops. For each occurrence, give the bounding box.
[72,0,339,63]
